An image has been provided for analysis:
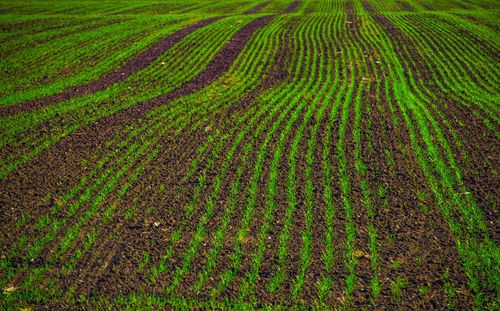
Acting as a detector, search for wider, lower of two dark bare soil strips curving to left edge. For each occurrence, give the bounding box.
[1,1,300,304]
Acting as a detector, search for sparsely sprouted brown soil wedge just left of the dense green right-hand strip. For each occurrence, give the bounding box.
[364,81,472,309]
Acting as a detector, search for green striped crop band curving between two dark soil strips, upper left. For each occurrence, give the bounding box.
[1,17,266,180]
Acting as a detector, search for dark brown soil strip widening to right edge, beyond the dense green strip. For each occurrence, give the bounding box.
[365,3,500,243]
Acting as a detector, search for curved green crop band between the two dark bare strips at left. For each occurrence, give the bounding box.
[0,18,264,180]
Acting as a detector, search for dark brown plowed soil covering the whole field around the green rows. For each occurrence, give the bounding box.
[0,1,500,310]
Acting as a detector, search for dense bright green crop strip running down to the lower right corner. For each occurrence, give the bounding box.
[362,8,498,305]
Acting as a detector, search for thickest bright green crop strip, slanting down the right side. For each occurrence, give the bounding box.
[362,3,498,305]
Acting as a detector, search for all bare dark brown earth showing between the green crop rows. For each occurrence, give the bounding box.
[0,2,500,310]
